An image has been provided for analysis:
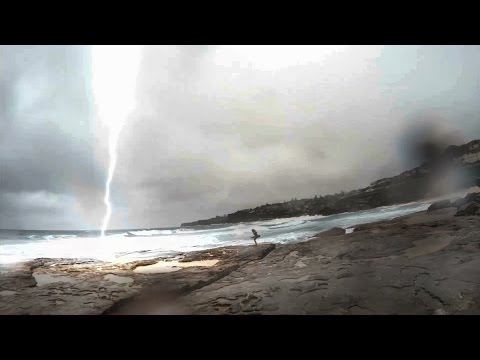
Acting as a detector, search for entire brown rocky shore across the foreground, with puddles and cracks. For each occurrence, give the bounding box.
[0,194,480,315]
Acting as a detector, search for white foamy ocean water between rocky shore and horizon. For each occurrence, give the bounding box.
[0,200,432,265]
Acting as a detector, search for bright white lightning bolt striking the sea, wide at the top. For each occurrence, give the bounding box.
[92,45,142,237]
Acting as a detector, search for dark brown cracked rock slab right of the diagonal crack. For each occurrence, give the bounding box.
[184,212,480,315]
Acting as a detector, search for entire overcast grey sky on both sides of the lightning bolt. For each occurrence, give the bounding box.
[0,46,480,229]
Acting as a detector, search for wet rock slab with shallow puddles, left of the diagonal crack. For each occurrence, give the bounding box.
[0,244,274,315]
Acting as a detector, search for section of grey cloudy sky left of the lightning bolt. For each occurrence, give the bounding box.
[0,46,103,229]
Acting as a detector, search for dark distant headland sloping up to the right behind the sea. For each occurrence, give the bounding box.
[181,140,480,227]
